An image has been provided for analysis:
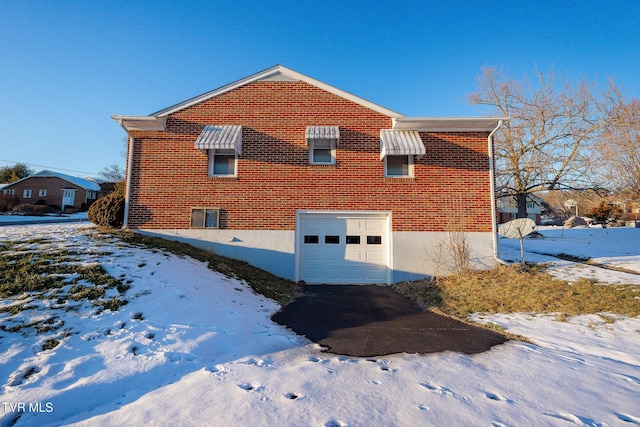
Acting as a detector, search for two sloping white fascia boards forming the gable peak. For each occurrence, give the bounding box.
[152,65,404,118]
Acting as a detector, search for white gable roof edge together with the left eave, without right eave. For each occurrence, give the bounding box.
[111,65,404,131]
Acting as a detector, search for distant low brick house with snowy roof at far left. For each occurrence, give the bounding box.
[2,170,101,211]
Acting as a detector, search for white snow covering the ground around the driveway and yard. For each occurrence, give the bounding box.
[0,224,640,427]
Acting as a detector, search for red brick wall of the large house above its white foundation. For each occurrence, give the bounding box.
[129,81,491,231]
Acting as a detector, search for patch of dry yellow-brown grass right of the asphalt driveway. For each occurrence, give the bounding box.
[396,266,640,318]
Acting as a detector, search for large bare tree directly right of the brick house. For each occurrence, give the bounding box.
[468,67,621,218]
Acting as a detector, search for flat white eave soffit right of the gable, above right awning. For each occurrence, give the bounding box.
[393,117,509,132]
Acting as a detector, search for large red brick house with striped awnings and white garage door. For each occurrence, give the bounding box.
[113,65,502,284]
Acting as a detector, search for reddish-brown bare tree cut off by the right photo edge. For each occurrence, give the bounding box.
[598,99,640,200]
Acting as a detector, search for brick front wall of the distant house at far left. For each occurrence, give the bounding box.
[5,176,94,209]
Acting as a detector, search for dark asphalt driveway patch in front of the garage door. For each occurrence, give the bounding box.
[271,285,508,357]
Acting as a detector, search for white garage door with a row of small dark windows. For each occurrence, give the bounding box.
[297,212,390,284]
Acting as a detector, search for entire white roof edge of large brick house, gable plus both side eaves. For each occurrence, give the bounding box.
[111,65,508,133]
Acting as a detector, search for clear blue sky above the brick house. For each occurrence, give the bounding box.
[0,0,640,176]
